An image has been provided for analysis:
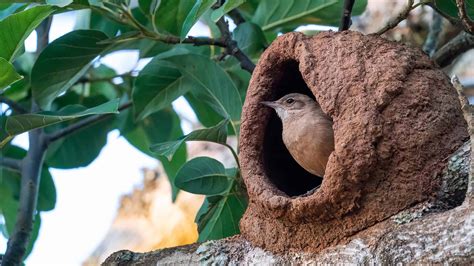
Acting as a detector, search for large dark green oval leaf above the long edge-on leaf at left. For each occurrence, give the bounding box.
[31,30,108,110]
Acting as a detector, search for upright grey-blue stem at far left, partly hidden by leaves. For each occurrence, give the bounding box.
[2,16,53,266]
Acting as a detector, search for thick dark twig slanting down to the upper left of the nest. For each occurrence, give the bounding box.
[216,17,255,73]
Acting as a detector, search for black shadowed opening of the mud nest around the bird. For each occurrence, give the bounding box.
[263,60,322,197]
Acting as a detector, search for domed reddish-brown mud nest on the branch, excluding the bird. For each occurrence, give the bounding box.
[240,31,468,252]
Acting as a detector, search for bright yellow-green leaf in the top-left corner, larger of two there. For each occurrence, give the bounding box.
[0,6,55,62]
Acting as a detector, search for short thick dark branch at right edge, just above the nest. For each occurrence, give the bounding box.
[432,31,474,67]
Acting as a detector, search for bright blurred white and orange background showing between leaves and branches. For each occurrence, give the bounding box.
[0,0,474,265]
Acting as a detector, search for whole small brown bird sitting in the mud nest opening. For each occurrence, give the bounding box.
[262,93,334,177]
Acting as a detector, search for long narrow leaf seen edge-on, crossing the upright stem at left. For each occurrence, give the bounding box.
[5,99,119,139]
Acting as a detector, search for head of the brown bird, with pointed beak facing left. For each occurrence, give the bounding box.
[261,93,320,120]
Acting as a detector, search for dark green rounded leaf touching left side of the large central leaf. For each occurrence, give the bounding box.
[132,58,190,119]
